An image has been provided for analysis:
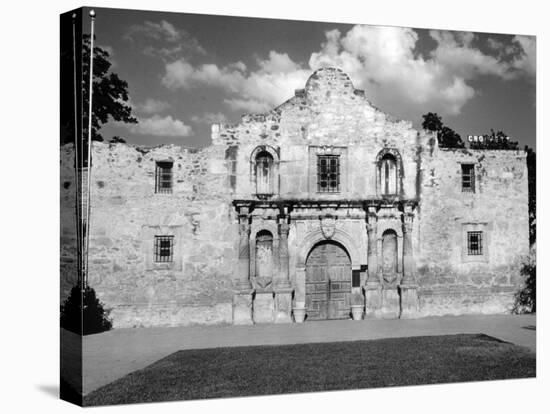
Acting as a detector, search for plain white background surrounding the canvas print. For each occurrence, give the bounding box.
[0,0,550,414]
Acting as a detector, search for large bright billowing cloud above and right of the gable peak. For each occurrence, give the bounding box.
[309,26,532,115]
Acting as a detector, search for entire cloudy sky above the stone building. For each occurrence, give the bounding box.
[85,9,536,148]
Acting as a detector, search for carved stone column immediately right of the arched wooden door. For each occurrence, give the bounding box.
[365,207,382,318]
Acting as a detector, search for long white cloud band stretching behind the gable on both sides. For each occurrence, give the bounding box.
[162,25,535,115]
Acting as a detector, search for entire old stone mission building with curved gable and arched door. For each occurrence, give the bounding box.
[61,68,529,327]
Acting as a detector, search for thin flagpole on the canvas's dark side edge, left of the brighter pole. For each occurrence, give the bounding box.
[72,13,82,288]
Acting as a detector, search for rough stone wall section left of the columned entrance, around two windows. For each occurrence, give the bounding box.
[62,143,238,327]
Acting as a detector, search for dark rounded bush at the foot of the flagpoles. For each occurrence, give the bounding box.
[61,285,113,335]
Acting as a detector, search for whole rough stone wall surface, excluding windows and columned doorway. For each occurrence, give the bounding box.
[61,69,528,327]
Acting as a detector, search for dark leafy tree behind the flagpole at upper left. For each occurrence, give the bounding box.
[82,35,138,141]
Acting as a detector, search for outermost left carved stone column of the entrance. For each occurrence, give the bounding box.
[233,207,253,325]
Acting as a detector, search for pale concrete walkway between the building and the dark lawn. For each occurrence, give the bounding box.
[83,315,536,395]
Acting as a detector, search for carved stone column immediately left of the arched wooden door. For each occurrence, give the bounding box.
[273,215,293,323]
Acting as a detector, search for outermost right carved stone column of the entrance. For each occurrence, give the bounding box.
[400,205,418,318]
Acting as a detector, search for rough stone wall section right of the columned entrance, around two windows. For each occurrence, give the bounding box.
[420,149,529,315]
